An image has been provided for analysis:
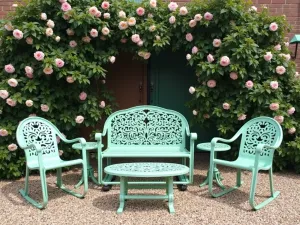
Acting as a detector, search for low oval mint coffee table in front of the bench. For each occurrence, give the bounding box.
[104,162,189,214]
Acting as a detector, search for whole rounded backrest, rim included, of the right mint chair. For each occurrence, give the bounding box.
[238,116,283,163]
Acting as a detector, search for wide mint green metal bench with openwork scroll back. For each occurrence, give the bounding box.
[95,105,197,191]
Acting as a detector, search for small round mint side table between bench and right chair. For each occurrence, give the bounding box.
[197,142,231,189]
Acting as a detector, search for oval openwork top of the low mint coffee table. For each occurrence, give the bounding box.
[104,162,189,177]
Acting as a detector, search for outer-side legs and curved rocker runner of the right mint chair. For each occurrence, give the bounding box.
[249,167,280,210]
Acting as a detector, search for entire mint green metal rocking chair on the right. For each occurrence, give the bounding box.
[209,116,283,210]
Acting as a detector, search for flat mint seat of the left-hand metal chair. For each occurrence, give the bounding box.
[27,158,83,170]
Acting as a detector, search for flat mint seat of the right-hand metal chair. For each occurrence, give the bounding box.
[214,157,271,170]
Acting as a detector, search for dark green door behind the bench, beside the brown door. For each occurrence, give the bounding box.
[148,50,216,143]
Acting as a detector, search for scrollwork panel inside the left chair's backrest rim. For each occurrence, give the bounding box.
[22,121,57,156]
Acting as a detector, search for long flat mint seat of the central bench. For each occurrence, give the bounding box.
[103,145,190,158]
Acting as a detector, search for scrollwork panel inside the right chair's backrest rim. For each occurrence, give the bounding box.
[241,121,276,156]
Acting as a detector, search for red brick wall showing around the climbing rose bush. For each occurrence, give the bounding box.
[0,0,300,67]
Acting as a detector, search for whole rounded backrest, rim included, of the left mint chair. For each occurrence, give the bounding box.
[17,117,59,162]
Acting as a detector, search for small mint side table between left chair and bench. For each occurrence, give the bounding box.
[72,142,99,188]
